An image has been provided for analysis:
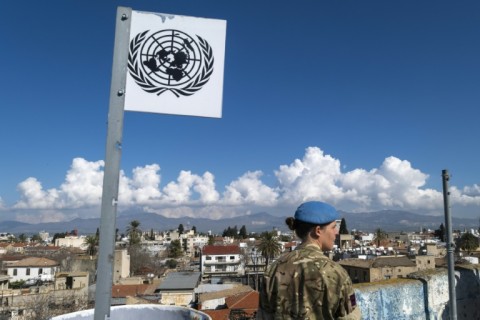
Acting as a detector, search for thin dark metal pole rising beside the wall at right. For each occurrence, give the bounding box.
[442,170,457,320]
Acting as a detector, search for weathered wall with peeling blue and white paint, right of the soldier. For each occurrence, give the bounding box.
[354,264,480,320]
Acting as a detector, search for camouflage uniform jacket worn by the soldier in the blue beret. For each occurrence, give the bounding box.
[257,244,361,320]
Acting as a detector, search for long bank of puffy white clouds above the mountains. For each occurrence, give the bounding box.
[6,147,480,221]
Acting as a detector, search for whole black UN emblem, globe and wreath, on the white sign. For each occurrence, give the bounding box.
[128,29,213,97]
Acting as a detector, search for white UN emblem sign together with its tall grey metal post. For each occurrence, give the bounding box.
[94,7,226,320]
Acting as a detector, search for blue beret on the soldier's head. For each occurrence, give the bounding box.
[294,201,340,224]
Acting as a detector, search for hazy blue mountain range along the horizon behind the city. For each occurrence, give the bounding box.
[0,210,479,234]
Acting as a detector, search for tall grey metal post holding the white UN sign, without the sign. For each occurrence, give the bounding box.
[94,7,132,320]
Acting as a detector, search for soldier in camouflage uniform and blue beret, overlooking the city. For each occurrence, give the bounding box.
[257,201,361,320]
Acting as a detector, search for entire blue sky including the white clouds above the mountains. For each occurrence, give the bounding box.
[0,0,480,222]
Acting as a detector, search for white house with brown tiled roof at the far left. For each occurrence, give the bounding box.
[7,257,59,282]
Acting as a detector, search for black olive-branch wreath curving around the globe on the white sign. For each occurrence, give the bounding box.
[128,30,214,98]
